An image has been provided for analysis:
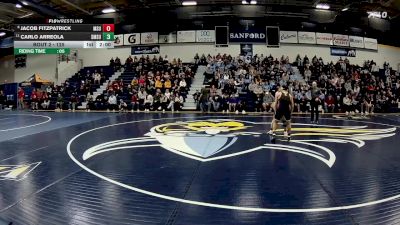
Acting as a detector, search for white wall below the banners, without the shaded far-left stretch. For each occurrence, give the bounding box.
[78,43,400,69]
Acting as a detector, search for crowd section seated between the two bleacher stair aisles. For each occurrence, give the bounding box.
[92,56,196,112]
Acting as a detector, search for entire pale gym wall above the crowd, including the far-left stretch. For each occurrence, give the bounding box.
[0,43,400,84]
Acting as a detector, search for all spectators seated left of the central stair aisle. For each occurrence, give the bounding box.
[9,56,197,111]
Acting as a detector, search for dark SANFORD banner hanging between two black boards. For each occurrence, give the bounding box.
[229,29,267,43]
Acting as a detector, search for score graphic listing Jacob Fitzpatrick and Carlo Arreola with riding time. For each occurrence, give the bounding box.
[14,18,114,55]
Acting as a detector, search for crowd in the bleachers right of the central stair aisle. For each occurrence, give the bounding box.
[194,54,400,115]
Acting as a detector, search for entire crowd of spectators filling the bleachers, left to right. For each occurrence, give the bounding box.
[4,51,400,115]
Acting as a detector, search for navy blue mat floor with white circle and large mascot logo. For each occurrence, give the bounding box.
[0,112,400,225]
